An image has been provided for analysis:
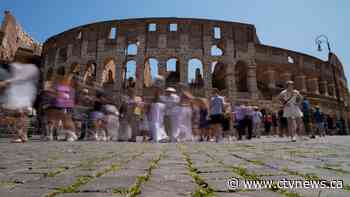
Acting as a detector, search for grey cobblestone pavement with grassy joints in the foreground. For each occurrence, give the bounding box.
[0,136,350,197]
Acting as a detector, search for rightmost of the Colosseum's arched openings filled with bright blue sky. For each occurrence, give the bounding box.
[187,58,204,88]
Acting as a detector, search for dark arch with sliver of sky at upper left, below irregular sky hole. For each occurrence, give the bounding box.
[212,62,226,91]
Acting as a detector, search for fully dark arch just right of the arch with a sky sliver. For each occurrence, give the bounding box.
[235,61,248,92]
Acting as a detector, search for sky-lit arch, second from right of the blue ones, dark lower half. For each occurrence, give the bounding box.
[166,58,180,86]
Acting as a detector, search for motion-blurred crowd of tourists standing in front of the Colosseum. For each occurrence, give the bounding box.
[0,64,344,143]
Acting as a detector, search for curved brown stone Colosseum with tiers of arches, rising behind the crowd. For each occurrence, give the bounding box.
[41,18,350,124]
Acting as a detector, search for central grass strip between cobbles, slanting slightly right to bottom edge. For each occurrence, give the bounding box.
[178,145,215,197]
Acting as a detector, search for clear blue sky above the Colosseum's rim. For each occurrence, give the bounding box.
[0,0,350,83]
